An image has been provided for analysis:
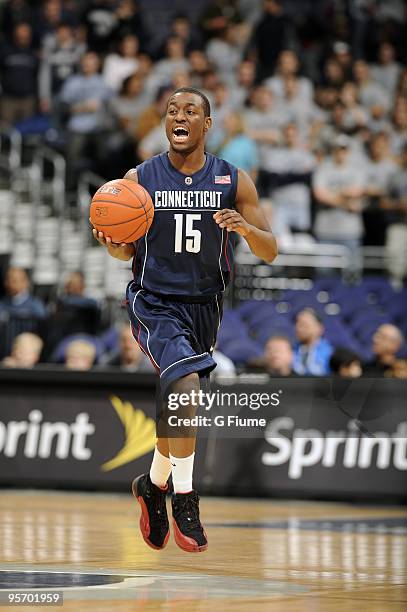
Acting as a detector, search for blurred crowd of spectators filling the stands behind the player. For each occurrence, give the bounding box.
[0,0,407,375]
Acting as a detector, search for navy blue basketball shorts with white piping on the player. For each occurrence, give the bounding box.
[126,282,222,396]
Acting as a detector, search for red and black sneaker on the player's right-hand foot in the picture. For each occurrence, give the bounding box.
[171,491,208,552]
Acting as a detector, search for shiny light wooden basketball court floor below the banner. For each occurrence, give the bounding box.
[0,489,407,612]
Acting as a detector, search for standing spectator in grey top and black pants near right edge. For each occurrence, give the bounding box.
[363,132,398,246]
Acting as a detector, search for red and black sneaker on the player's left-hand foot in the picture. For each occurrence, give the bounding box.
[131,474,170,550]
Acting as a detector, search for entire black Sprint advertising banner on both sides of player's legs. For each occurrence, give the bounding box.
[0,370,407,500]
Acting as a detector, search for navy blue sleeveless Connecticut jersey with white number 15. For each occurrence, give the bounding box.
[133,153,237,297]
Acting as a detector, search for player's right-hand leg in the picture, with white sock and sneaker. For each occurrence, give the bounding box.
[168,372,208,552]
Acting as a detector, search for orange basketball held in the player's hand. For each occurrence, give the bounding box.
[90,179,154,243]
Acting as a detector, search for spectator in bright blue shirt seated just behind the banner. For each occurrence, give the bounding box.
[293,308,333,376]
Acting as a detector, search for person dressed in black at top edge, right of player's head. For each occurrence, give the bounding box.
[250,0,291,81]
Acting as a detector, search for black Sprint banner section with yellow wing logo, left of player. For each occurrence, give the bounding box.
[0,372,162,488]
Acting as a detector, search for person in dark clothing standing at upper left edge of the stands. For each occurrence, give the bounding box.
[0,23,38,124]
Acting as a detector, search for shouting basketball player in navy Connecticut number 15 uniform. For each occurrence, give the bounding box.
[93,88,277,552]
